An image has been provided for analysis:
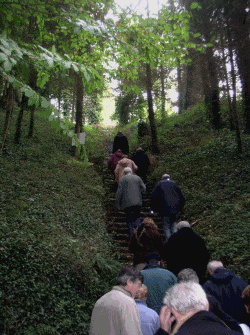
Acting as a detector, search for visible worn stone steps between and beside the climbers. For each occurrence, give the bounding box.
[104,171,163,265]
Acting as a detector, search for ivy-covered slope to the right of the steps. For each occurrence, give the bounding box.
[148,110,250,283]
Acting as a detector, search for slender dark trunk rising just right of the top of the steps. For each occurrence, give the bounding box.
[146,63,159,154]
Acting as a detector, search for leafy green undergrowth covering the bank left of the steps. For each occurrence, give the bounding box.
[0,114,120,334]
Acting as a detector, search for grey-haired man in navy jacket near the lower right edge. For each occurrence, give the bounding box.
[203,261,247,323]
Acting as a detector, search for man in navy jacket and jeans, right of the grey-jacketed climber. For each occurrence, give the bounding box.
[151,174,185,241]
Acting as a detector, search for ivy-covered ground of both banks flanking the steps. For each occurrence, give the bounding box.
[0,104,250,335]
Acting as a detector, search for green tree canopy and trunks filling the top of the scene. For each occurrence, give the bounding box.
[0,0,250,152]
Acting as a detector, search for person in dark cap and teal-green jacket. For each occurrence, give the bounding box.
[141,252,177,314]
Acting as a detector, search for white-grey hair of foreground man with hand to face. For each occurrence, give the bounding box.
[163,282,208,315]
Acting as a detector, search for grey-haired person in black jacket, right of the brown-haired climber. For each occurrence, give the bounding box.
[164,221,209,284]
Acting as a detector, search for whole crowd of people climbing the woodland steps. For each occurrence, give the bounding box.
[89,131,250,335]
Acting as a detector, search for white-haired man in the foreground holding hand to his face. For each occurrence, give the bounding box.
[156,282,242,335]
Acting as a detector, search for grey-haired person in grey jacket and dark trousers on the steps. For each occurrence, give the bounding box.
[115,167,146,238]
